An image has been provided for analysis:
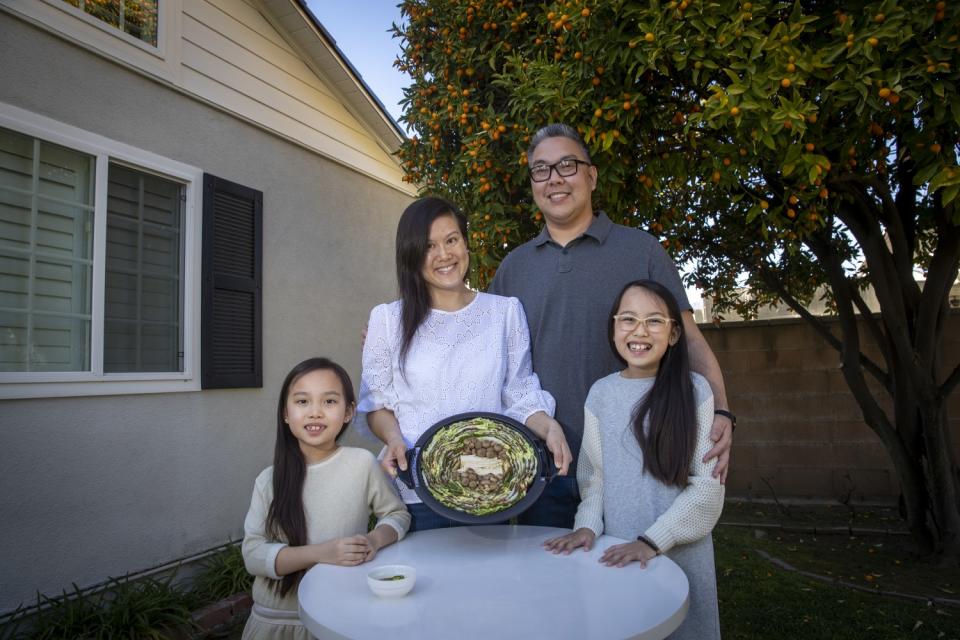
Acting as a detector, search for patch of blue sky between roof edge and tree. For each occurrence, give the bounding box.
[307,0,410,120]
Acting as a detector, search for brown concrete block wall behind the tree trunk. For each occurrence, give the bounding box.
[701,312,960,502]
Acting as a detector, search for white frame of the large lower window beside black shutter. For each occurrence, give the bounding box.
[0,102,203,399]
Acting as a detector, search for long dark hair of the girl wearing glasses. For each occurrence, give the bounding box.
[607,280,697,487]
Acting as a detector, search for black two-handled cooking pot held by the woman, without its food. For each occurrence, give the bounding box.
[398,412,556,524]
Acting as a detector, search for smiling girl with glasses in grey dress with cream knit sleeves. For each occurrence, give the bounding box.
[544,280,724,639]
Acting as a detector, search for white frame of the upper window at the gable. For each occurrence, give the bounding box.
[0,0,183,83]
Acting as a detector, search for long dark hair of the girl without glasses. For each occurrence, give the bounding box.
[266,358,356,597]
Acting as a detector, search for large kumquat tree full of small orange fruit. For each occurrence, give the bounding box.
[395,0,960,563]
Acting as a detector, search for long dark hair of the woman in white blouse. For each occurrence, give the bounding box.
[397,196,470,363]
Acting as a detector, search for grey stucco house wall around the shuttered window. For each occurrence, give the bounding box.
[0,12,410,613]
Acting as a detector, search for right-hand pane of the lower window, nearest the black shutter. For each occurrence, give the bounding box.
[104,164,183,372]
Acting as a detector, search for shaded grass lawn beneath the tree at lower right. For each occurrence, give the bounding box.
[714,503,960,640]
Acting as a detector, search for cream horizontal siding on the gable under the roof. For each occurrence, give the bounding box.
[0,0,415,195]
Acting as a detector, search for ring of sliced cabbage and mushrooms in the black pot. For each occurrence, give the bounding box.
[420,418,537,516]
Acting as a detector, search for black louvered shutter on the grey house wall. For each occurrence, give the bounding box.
[200,174,263,389]
